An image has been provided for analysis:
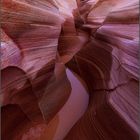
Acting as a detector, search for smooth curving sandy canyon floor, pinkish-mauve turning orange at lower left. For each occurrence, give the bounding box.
[22,68,89,140]
